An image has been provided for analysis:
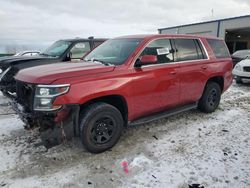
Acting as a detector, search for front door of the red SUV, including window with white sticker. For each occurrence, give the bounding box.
[132,39,180,117]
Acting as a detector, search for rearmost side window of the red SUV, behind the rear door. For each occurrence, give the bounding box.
[207,39,230,58]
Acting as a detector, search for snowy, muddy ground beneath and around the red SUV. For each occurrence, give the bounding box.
[0,81,250,188]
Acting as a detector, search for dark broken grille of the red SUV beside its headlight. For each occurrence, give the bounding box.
[16,81,35,112]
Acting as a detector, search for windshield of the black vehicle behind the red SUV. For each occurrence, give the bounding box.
[41,40,71,57]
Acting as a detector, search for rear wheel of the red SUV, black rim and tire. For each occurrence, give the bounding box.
[198,82,221,113]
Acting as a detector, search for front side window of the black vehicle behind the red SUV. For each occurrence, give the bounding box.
[70,42,90,59]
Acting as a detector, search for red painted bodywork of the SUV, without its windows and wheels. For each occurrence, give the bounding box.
[16,35,232,121]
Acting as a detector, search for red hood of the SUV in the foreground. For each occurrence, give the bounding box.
[15,61,115,84]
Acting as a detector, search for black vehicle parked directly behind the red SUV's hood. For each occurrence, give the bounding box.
[0,37,106,96]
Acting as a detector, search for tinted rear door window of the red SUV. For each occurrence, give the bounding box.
[174,39,202,61]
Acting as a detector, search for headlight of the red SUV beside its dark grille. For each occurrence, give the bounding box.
[34,84,70,111]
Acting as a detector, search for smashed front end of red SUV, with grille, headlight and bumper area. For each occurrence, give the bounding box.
[12,81,79,148]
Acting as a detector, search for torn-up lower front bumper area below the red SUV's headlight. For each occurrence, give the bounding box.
[12,100,80,148]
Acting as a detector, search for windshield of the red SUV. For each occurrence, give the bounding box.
[84,39,142,65]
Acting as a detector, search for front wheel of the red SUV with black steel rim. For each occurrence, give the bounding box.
[80,103,124,153]
